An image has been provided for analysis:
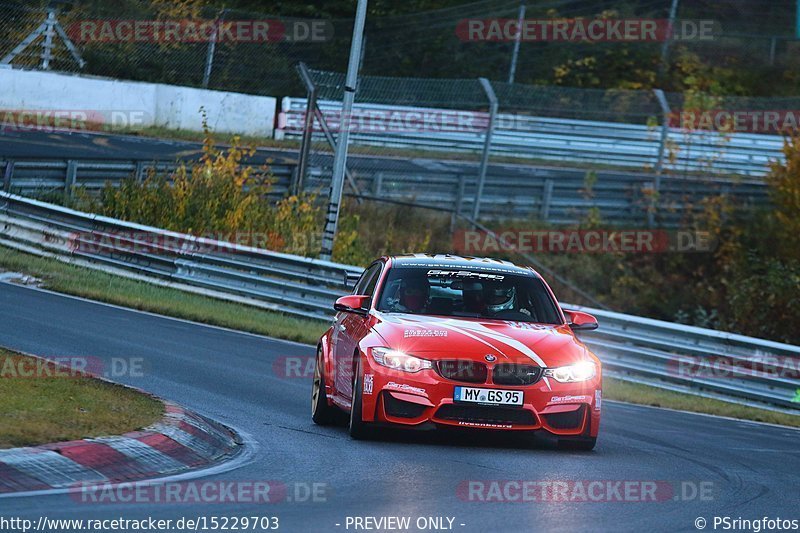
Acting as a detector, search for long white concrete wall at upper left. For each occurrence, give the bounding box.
[0,68,277,137]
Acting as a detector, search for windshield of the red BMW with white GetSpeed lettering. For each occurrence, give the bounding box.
[377,265,561,324]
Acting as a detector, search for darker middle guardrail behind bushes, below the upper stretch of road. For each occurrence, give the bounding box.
[0,157,770,227]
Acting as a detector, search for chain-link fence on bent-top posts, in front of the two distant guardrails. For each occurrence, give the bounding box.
[279,68,780,234]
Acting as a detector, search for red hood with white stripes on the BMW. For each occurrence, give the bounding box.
[373,313,590,367]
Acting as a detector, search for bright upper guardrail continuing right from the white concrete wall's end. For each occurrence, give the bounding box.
[276,97,783,176]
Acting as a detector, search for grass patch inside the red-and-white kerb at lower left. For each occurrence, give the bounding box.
[0,348,164,448]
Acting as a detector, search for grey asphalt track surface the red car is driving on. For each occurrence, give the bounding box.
[0,283,800,532]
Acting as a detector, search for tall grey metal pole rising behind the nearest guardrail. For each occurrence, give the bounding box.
[319,0,368,261]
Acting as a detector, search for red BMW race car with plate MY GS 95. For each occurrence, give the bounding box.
[312,254,602,450]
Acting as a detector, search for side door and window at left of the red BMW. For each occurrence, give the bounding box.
[333,263,382,401]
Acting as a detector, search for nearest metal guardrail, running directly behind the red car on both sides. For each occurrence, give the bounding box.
[0,193,800,414]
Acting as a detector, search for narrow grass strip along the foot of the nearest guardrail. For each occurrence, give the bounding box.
[0,247,800,427]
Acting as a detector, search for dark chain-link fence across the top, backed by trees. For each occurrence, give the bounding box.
[0,0,800,97]
